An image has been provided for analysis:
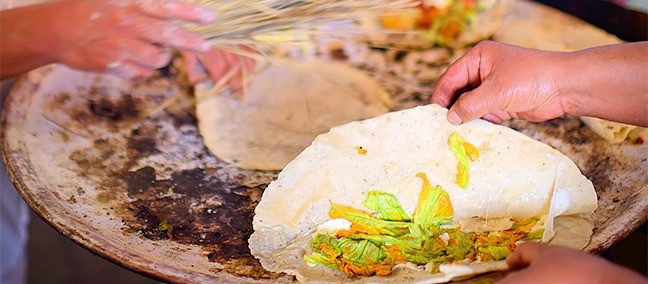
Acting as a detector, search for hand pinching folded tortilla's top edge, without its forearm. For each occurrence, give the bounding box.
[431,41,565,124]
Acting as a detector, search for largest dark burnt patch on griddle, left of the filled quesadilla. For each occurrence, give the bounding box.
[70,118,281,279]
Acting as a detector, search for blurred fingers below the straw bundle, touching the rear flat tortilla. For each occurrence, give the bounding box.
[182,48,256,92]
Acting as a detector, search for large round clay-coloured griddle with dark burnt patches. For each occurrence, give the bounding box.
[1,2,648,283]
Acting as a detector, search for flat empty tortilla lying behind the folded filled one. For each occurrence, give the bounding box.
[195,60,391,170]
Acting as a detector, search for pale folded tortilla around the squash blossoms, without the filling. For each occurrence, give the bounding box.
[249,105,597,283]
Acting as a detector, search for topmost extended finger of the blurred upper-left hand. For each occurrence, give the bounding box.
[137,0,216,24]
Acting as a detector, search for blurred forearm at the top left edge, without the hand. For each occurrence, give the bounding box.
[0,4,56,79]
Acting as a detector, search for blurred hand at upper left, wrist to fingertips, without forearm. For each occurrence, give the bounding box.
[48,0,215,78]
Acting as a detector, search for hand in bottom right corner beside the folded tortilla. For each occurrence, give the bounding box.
[497,243,646,284]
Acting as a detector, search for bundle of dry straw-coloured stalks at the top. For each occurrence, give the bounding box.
[191,0,418,52]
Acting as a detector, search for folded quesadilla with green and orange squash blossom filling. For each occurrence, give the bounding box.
[249,105,597,283]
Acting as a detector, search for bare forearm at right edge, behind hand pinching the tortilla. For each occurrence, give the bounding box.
[558,42,648,126]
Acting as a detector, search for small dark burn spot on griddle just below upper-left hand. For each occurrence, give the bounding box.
[88,95,139,121]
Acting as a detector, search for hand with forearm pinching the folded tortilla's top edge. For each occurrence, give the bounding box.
[431,42,648,126]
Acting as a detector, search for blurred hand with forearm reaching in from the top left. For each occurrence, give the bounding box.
[0,0,215,79]
